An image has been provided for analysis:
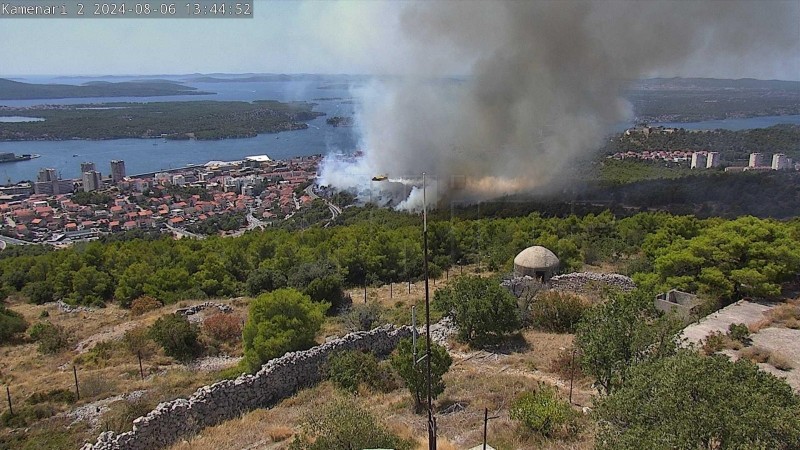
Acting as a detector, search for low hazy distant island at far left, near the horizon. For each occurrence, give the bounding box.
[0,78,213,100]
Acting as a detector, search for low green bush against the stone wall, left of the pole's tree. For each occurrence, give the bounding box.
[323,350,395,393]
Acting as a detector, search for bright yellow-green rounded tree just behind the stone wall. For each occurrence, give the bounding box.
[243,289,328,372]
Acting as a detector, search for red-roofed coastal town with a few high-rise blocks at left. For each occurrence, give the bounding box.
[0,155,328,246]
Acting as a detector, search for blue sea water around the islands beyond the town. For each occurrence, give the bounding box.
[0,76,800,184]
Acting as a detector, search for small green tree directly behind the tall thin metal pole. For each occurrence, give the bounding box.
[391,338,453,412]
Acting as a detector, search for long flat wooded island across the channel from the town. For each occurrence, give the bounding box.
[0,100,324,141]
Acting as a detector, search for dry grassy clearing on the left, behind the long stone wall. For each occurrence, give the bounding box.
[0,301,244,439]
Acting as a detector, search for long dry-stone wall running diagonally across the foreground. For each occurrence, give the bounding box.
[83,325,411,450]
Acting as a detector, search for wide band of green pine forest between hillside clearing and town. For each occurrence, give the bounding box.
[0,207,800,312]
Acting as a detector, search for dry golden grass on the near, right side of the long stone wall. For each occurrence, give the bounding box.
[166,324,594,450]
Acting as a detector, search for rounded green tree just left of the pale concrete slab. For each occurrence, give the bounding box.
[575,290,682,394]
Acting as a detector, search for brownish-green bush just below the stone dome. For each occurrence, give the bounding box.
[530,291,589,333]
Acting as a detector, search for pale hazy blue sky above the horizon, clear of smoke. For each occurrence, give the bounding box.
[0,0,800,80]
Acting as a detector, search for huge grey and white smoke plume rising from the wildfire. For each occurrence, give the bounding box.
[321,1,800,208]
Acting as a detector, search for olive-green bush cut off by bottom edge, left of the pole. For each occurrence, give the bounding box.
[289,399,412,450]
